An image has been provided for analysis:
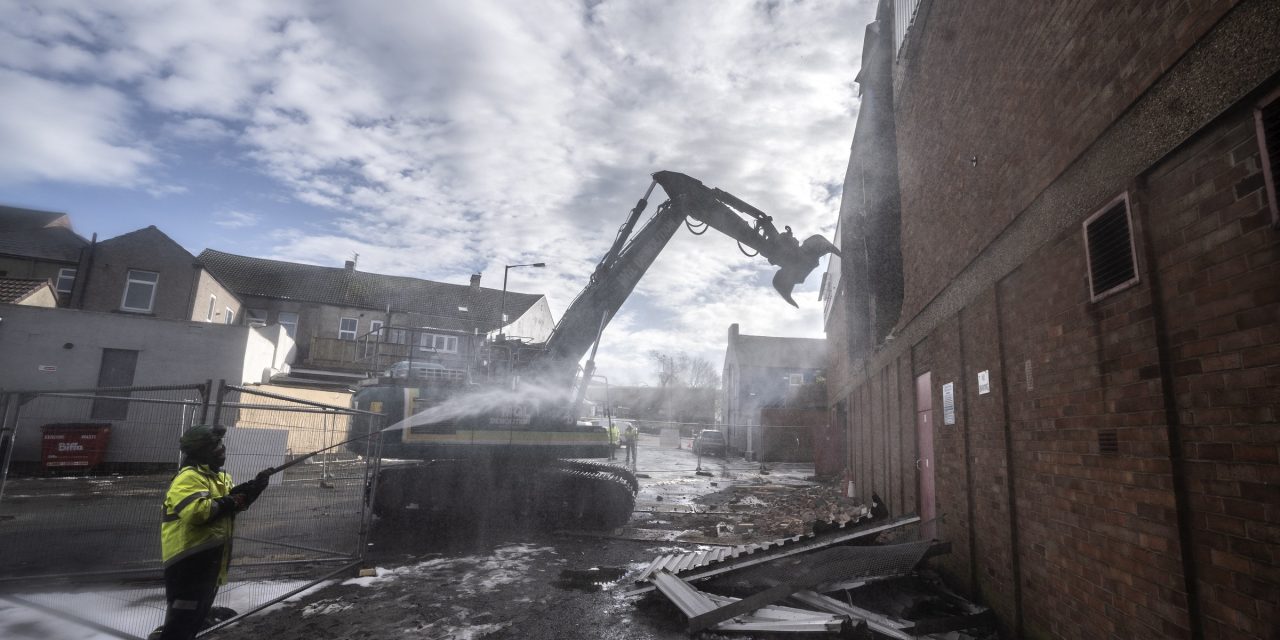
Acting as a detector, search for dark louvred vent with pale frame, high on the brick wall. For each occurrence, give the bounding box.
[1084,195,1138,301]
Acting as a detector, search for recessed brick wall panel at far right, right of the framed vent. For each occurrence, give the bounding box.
[1139,109,1280,637]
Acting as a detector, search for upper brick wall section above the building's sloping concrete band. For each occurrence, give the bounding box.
[896,0,1235,319]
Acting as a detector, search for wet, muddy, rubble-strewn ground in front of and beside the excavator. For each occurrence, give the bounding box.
[216,439,860,640]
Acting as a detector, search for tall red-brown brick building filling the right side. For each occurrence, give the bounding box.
[827,0,1280,639]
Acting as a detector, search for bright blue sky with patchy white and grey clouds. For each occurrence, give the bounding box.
[0,0,874,384]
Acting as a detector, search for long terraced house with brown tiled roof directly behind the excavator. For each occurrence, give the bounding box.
[200,250,554,384]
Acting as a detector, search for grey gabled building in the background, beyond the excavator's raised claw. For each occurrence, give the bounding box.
[721,324,827,460]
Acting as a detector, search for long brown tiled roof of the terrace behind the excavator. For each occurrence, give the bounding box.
[197,248,543,330]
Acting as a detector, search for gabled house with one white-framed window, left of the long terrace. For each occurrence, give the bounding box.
[72,225,241,325]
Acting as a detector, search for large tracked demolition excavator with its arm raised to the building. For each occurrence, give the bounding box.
[348,172,837,529]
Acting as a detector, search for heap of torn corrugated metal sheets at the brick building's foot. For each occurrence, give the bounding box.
[626,516,997,640]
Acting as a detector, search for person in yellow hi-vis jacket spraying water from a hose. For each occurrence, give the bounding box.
[152,425,270,640]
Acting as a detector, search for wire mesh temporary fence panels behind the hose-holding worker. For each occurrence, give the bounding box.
[0,383,379,639]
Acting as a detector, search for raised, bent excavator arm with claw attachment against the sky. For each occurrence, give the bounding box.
[543,172,837,379]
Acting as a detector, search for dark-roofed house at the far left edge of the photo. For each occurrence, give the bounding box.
[0,206,88,306]
